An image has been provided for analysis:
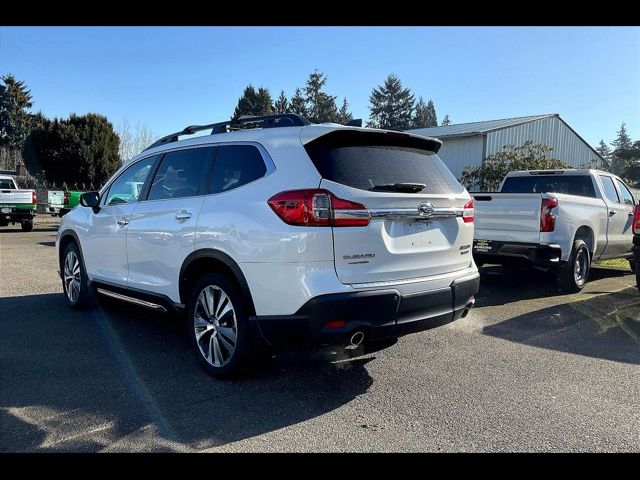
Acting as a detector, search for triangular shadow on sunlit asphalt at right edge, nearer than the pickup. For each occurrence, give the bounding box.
[482,288,640,364]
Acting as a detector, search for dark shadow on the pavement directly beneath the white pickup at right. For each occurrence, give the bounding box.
[475,265,635,307]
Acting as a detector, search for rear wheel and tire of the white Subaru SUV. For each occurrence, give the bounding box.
[186,273,252,378]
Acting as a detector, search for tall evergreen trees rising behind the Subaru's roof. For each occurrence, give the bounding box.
[232,70,451,130]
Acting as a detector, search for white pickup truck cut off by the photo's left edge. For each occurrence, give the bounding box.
[0,175,38,232]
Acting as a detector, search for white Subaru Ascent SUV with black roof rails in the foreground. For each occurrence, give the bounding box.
[56,114,479,376]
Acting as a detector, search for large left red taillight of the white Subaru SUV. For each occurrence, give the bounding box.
[268,189,371,227]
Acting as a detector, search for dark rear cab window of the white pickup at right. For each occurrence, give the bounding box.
[500,175,596,198]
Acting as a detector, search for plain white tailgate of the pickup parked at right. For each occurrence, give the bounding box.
[473,193,542,243]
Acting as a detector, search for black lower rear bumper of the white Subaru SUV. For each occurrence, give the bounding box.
[255,272,480,344]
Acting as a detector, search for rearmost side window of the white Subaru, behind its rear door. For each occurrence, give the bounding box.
[211,145,267,193]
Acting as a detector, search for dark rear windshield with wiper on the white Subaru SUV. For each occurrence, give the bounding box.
[305,130,464,194]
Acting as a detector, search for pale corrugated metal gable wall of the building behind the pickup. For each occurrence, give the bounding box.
[485,117,598,167]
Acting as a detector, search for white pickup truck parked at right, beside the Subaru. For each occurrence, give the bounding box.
[472,169,635,292]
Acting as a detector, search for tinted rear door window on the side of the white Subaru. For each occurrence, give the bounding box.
[147,147,213,200]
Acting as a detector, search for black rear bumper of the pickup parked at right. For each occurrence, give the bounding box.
[473,240,562,266]
